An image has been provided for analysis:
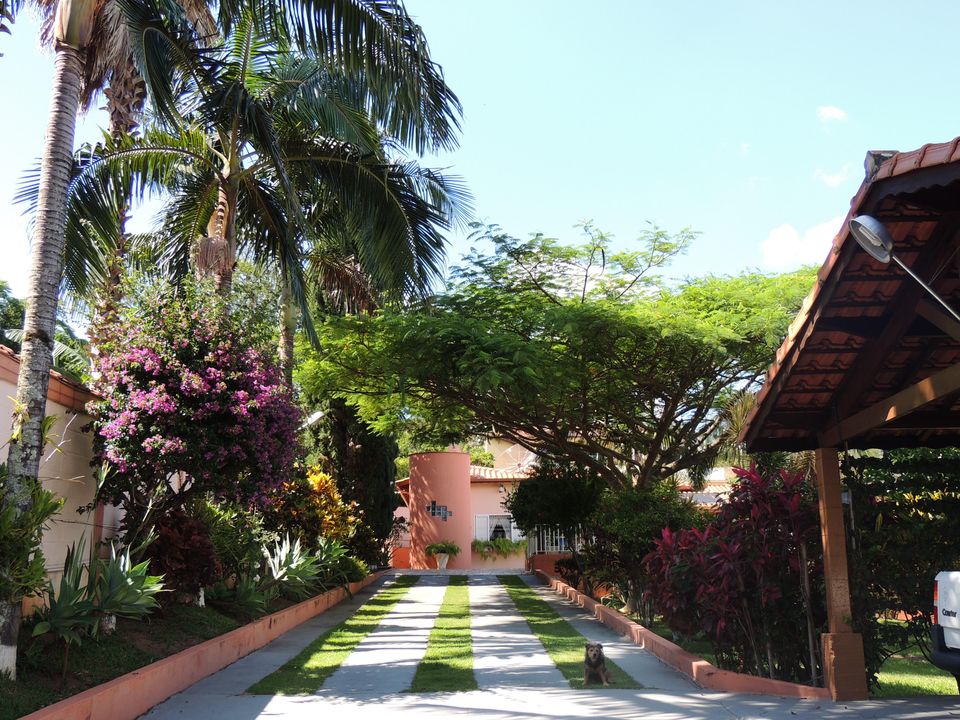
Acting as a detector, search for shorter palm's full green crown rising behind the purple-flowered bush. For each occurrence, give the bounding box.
[54,28,468,380]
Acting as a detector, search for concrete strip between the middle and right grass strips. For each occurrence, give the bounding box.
[469,575,569,689]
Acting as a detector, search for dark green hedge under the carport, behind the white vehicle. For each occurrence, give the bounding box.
[843,448,960,685]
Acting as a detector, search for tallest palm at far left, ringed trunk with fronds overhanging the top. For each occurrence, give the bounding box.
[0,0,460,673]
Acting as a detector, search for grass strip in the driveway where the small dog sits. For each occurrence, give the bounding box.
[497,575,643,689]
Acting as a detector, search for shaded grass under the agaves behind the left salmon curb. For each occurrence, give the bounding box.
[0,605,240,720]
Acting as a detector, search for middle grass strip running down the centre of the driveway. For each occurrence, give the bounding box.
[410,575,477,692]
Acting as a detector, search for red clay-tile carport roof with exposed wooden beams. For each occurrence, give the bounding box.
[741,138,960,451]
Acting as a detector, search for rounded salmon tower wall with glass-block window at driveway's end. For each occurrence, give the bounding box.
[410,452,473,570]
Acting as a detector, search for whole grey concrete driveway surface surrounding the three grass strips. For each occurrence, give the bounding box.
[144,574,960,720]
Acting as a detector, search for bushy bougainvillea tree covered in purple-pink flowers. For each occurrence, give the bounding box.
[92,284,300,544]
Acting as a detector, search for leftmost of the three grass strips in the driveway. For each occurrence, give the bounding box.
[247,575,420,695]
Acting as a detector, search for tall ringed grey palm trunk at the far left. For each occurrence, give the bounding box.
[0,40,83,673]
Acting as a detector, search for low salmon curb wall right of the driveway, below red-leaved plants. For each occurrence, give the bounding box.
[537,570,830,700]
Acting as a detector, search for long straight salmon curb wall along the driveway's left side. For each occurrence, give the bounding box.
[21,572,384,720]
